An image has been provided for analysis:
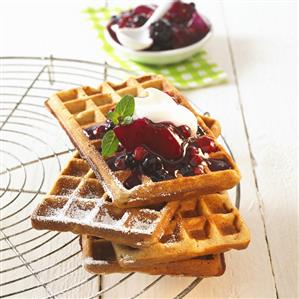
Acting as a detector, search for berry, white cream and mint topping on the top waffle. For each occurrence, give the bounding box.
[84,88,231,189]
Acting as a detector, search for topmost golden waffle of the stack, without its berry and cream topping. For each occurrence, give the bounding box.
[46,75,240,207]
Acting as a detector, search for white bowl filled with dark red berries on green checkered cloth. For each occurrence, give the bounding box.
[105,1,212,65]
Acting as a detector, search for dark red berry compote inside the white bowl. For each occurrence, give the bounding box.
[107,1,210,51]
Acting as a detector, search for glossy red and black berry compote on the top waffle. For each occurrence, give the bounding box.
[84,118,231,189]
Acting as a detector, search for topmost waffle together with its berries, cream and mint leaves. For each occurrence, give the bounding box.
[46,75,240,208]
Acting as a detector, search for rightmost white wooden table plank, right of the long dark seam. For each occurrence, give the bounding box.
[224,1,298,298]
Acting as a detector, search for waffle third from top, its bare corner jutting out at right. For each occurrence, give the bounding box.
[113,193,250,267]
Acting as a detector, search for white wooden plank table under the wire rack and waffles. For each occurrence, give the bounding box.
[0,0,299,298]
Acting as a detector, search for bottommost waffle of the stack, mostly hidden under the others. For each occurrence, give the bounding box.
[82,235,225,277]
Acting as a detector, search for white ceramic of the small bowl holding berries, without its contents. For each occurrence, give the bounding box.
[105,15,212,65]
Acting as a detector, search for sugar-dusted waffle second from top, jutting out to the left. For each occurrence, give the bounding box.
[31,153,179,247]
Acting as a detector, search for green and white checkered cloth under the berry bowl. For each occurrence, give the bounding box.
[84,8,226,89]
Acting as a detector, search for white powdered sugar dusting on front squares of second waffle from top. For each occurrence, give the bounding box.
[36,196,163,235]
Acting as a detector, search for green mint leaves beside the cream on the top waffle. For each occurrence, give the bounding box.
[102,95,135,158]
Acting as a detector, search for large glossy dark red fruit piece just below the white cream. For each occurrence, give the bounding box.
[114,118,183,160]
